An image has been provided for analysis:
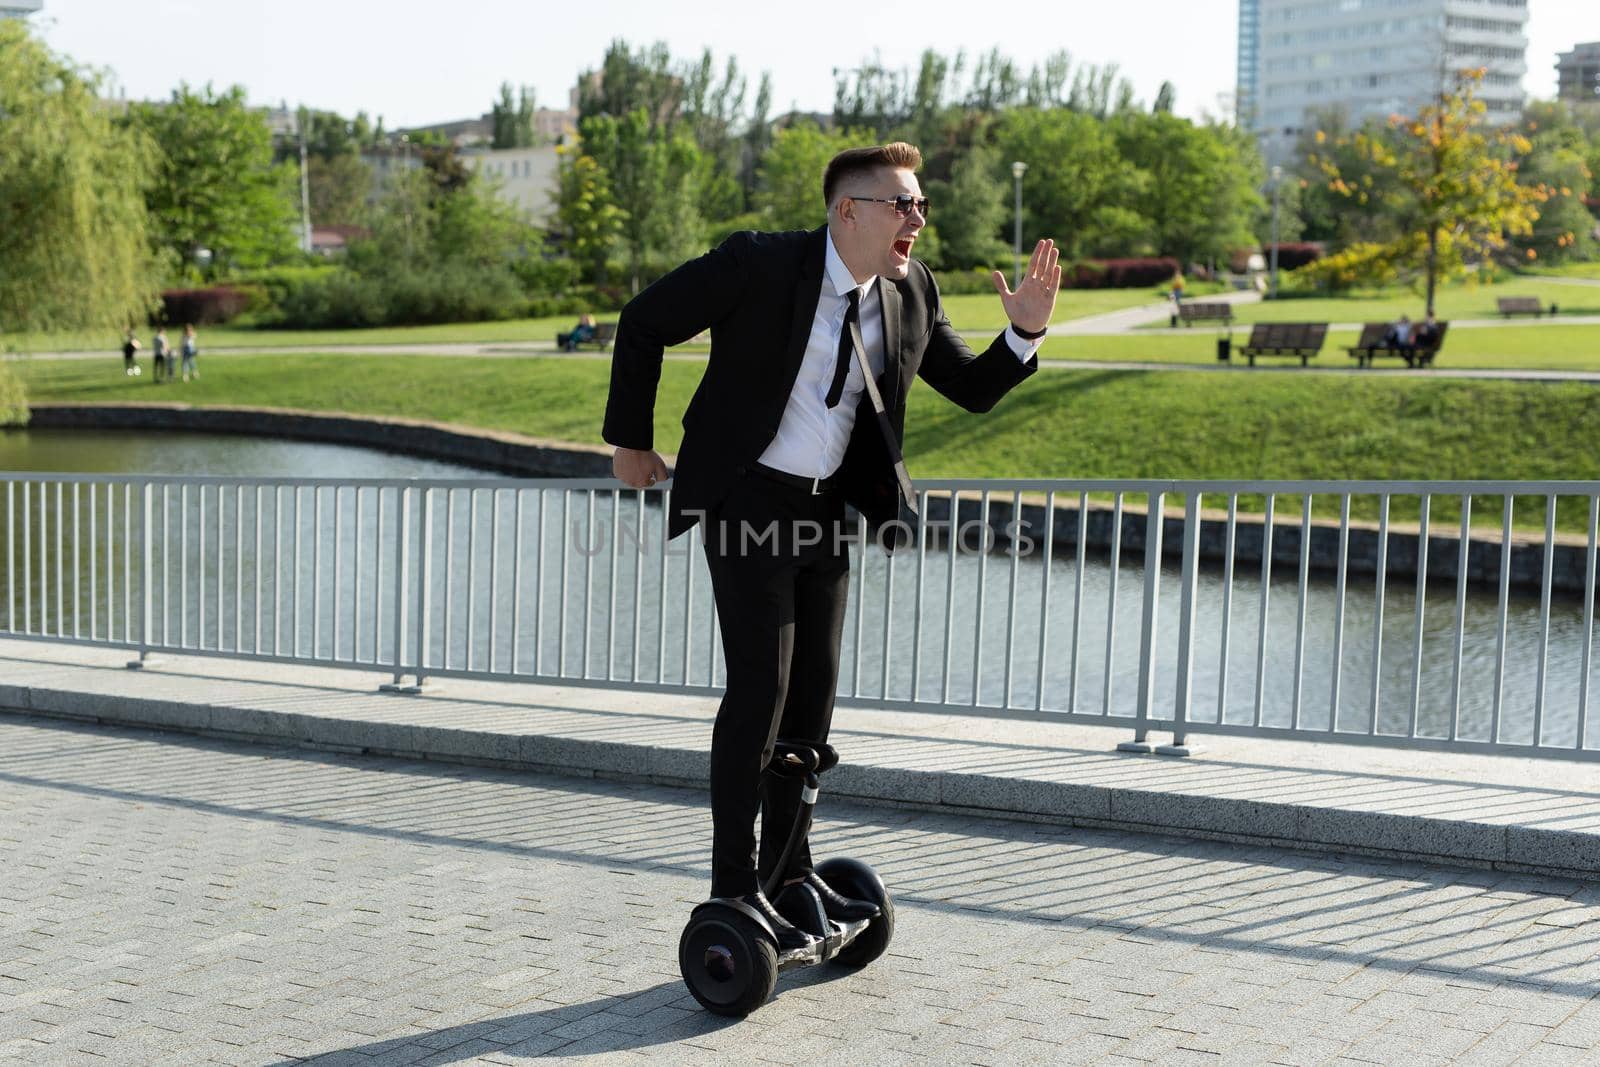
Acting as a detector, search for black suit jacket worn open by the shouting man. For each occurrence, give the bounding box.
[603,227,1038,537]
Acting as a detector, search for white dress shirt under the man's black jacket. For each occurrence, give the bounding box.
[762,232,1043,478]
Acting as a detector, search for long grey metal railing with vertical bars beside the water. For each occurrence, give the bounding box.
[0,474,1600,758]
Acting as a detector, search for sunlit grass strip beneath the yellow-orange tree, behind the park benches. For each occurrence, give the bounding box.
[1234,278,1600,323]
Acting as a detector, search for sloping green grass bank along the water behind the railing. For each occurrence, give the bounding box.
[16,350,1600,530]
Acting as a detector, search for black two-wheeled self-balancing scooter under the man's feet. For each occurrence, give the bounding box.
[678,741,894,1017]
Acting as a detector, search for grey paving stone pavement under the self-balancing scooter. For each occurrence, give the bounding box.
[0,718,1600,1065]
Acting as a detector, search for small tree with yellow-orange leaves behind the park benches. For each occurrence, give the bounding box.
[1322,69,1547,312]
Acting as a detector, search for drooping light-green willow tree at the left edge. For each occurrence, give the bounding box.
[0,19,157,331]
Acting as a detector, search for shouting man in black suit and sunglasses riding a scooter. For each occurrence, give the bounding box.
[603,142,1061,950]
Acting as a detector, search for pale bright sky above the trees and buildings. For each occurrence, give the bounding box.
[32,0,1600,130]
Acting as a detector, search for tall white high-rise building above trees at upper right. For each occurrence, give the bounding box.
[1238,0,1528,162]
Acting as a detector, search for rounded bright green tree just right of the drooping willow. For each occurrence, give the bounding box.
[126,85,299,279]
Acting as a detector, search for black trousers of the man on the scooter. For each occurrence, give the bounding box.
[704,474,850,896]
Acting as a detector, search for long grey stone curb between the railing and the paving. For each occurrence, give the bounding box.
[0,685,1600,880]
